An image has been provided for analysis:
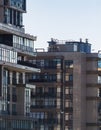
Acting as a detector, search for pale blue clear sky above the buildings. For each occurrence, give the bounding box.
[23,0,101,52]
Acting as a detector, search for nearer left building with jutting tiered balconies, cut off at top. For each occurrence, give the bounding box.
[0,0,40,130]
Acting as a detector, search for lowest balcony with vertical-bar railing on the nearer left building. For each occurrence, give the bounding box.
[0,116,34,130]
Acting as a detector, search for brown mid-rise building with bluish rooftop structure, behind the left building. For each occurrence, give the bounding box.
[29,39,101,130]
